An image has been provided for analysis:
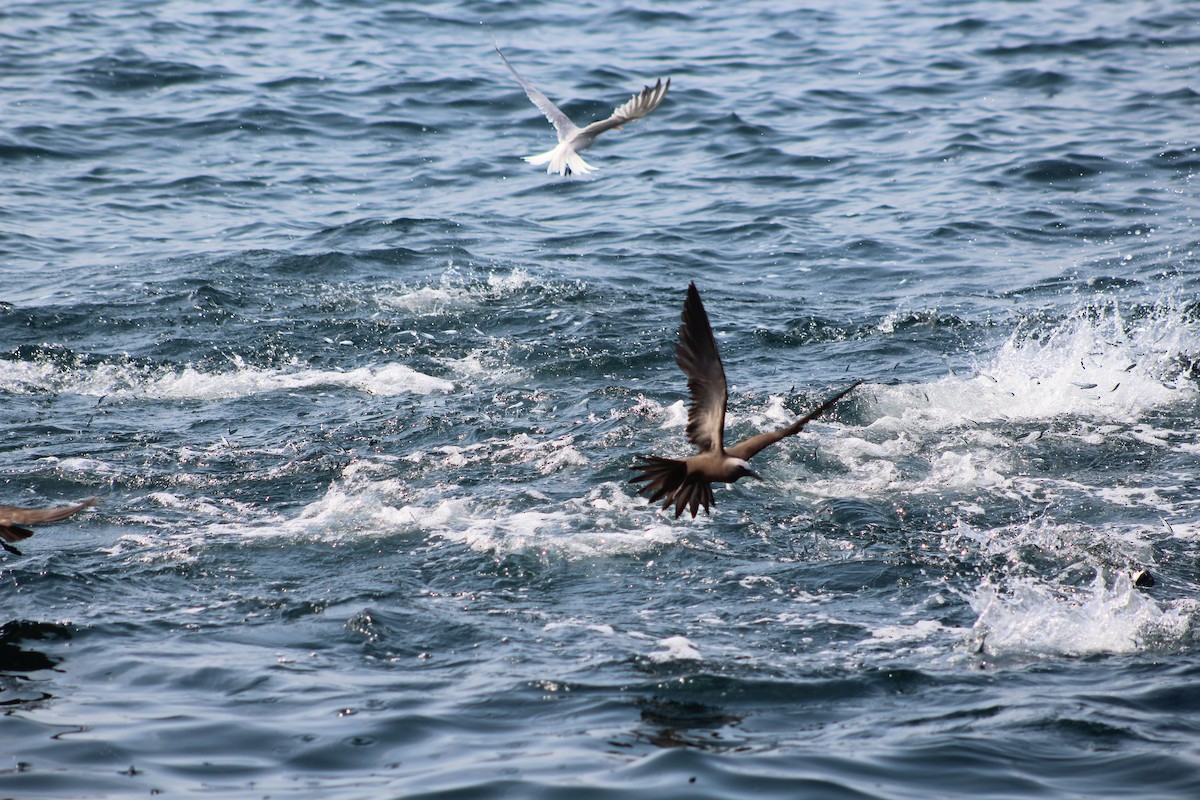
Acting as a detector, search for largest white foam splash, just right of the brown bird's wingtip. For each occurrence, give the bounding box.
[806,303,1200,512]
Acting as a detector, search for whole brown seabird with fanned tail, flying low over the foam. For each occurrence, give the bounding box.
[629,283,862,519]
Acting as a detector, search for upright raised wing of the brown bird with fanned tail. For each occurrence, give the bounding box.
[676,283,728,452]
